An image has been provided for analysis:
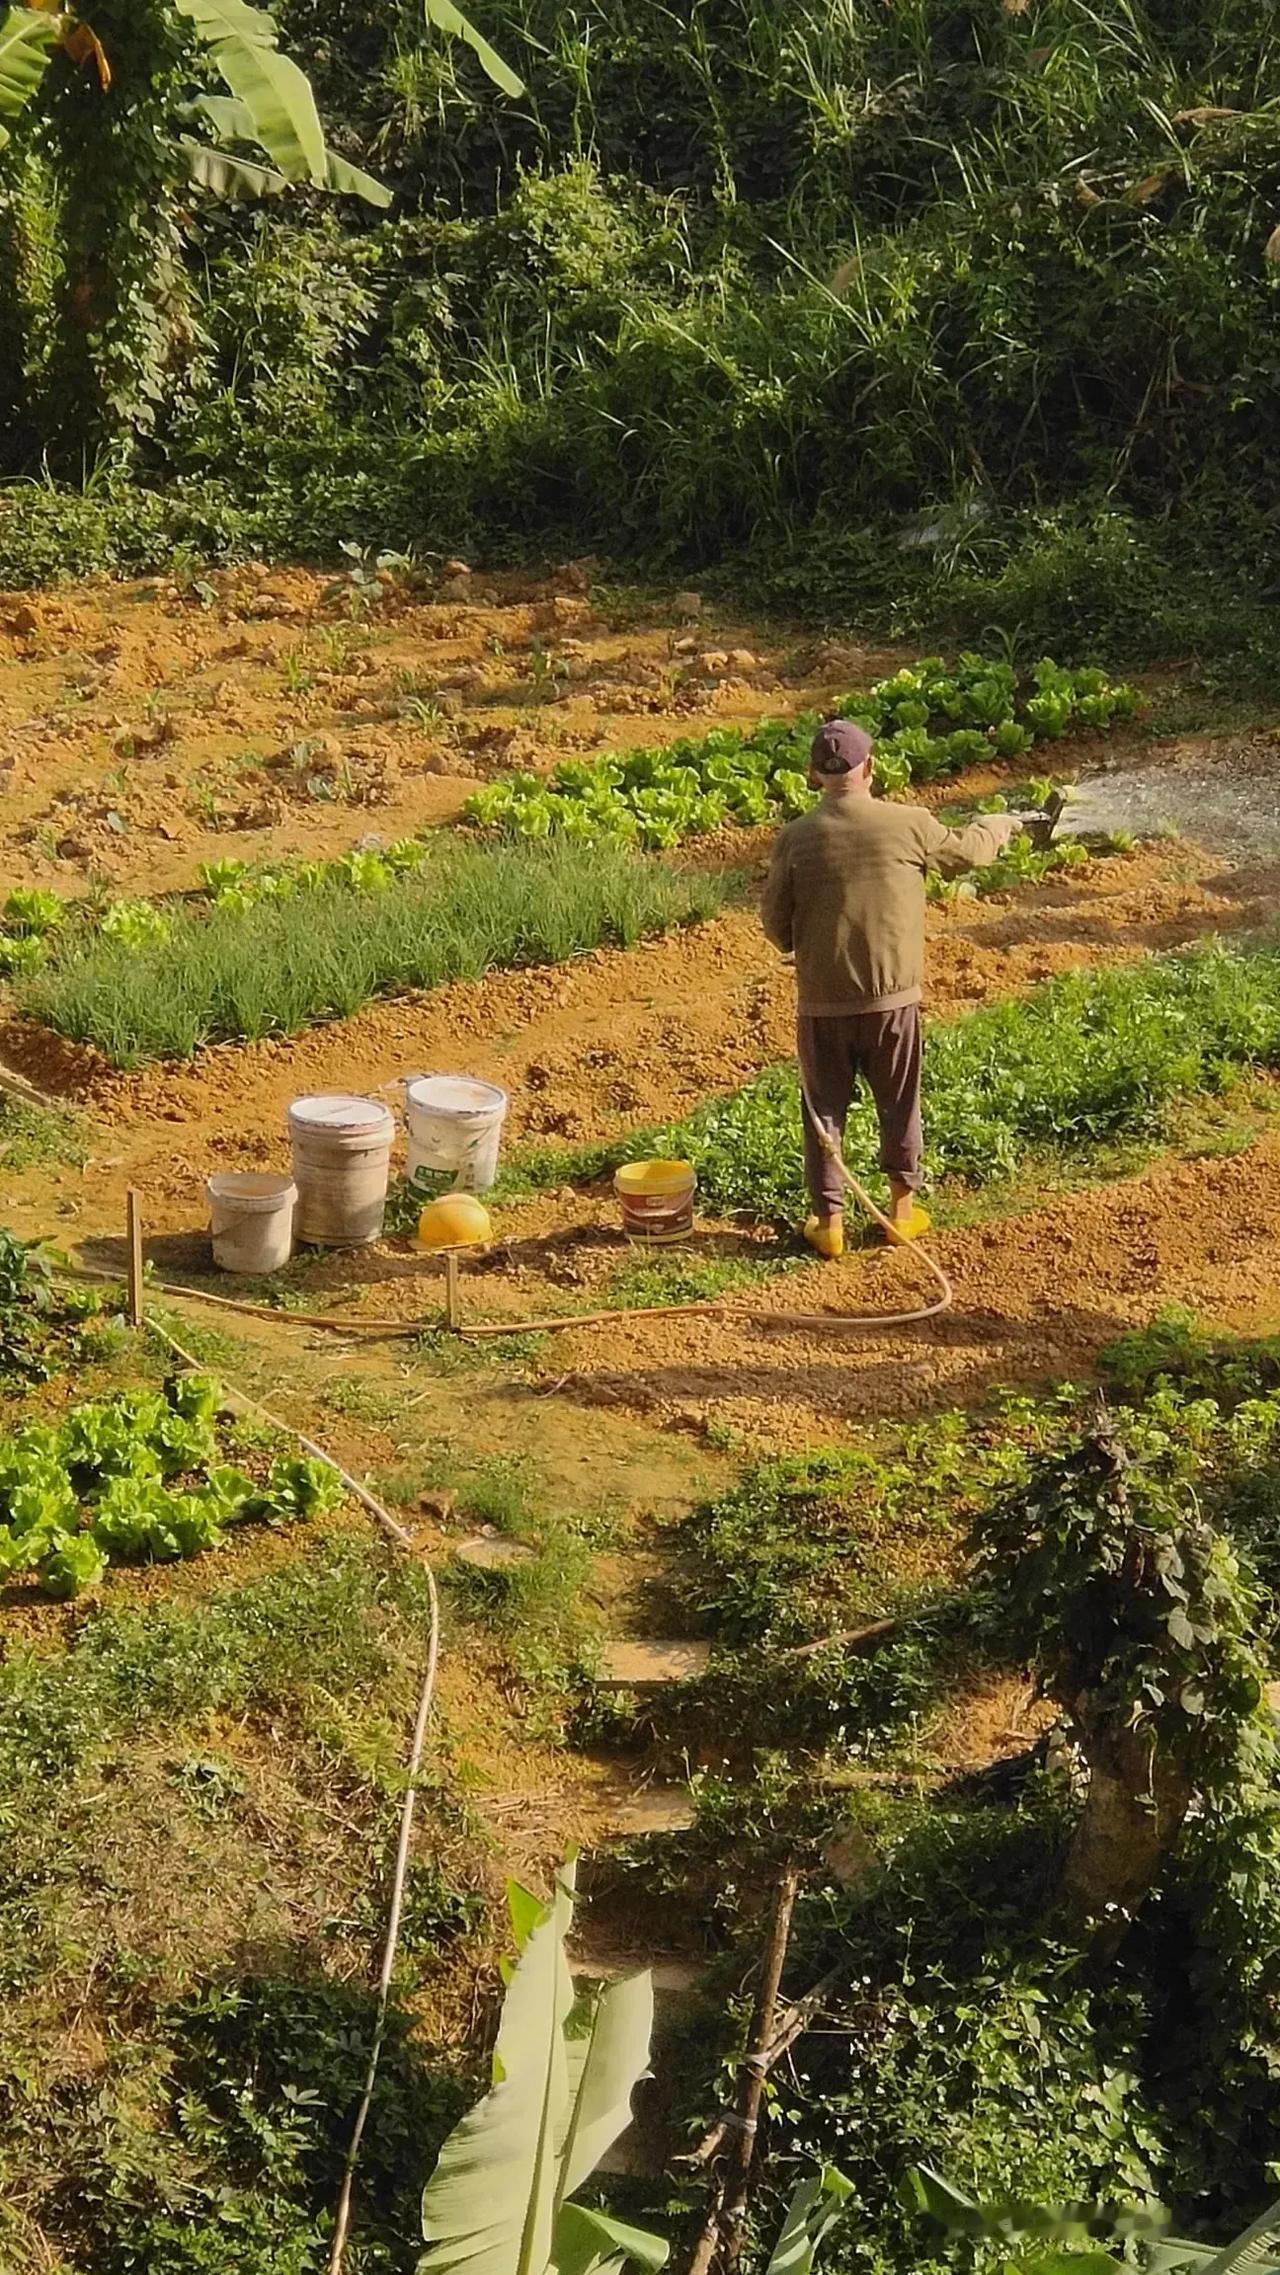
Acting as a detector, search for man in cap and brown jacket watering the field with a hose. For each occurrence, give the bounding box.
[762,719,1021,1256]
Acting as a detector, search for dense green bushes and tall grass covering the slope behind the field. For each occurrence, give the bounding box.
[0,0,1280,651]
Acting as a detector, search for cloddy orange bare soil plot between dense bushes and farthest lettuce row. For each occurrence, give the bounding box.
[0,569,878,894]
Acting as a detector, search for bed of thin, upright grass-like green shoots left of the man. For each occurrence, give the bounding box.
[18,844,732,1067]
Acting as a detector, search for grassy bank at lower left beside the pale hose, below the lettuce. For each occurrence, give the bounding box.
[0,1531,482,2275]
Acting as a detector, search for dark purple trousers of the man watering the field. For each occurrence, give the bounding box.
[796,1003,923,1217]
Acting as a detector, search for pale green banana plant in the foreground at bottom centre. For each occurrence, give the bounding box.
[418,1859,850,2275]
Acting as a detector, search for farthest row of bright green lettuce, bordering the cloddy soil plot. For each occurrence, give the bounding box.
[0,655,1139,981]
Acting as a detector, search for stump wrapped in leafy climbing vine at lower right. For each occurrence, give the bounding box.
[971,1404,1275,1916]
